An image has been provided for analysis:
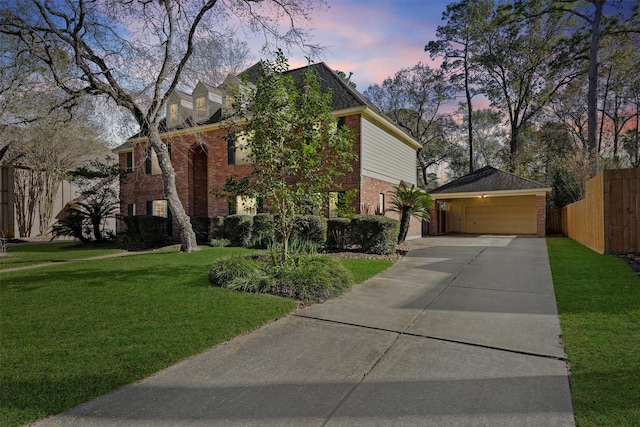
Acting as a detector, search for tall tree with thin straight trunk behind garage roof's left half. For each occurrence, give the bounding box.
[424,0,493,173]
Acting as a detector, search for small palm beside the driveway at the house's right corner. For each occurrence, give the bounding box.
[389,181,433,243]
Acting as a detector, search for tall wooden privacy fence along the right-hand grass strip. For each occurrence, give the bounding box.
[562,169,640,253]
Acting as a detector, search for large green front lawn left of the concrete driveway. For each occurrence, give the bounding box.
[0,246,391,426]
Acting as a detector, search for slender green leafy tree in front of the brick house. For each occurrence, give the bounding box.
[234,51,355,261]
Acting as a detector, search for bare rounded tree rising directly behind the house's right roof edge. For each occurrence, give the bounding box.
[363,63,451,185]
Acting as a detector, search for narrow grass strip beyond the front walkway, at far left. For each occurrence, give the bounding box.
[0,242,124,270]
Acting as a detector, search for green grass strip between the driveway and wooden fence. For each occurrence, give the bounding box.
[547,238,640,427]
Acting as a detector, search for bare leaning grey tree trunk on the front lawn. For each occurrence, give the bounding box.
[148,125,199,253]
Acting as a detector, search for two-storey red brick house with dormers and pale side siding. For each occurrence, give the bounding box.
[114,63,421,237]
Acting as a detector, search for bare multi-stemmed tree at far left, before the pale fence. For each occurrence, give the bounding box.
[0,98,107,237]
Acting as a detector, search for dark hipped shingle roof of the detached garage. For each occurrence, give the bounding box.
[430,166,548,194]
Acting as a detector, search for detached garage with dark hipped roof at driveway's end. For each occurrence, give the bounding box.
[429,166,551,237]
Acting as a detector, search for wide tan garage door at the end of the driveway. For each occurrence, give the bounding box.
[464,206,537,234]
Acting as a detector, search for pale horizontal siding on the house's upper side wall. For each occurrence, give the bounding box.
[361,117,417,184]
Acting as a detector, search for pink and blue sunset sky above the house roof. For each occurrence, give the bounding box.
[252,0,453,92]
